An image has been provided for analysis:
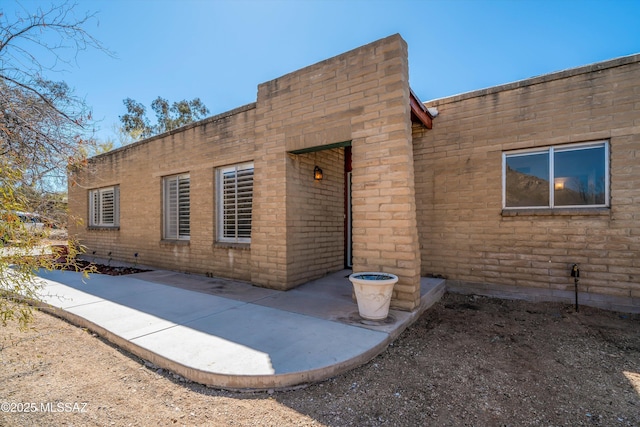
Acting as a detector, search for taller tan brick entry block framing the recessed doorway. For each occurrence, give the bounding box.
[251,35,420,309]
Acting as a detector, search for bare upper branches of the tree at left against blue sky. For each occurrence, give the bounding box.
[0,2,111,195]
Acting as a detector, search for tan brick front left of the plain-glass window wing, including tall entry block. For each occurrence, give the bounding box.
[70,35,420,309]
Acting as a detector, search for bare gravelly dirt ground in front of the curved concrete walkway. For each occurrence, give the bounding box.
[0,294,640,427]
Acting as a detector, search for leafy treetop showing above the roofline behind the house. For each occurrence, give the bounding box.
[120,96,209,140]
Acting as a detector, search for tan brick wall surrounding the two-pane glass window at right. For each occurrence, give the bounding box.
[413,55,640,310]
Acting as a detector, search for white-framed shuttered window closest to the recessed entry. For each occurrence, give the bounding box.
[216,163,253,243]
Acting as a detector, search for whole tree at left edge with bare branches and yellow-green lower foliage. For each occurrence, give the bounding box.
[0,3,108,328]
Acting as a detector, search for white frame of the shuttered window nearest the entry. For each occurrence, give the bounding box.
[216,162,255,244]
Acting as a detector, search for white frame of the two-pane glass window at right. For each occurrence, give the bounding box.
[502,140,611,211]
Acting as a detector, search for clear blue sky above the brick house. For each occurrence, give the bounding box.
[0,0,640,141]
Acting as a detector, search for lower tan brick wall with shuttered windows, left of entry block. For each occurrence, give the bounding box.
[69,104,255,280]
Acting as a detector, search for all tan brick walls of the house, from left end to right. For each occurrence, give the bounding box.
[69,35,640,310]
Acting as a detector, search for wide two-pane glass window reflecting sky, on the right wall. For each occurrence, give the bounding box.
[502,141,609,209]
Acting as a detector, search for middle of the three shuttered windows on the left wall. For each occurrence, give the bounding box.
[163,174,191,240]
